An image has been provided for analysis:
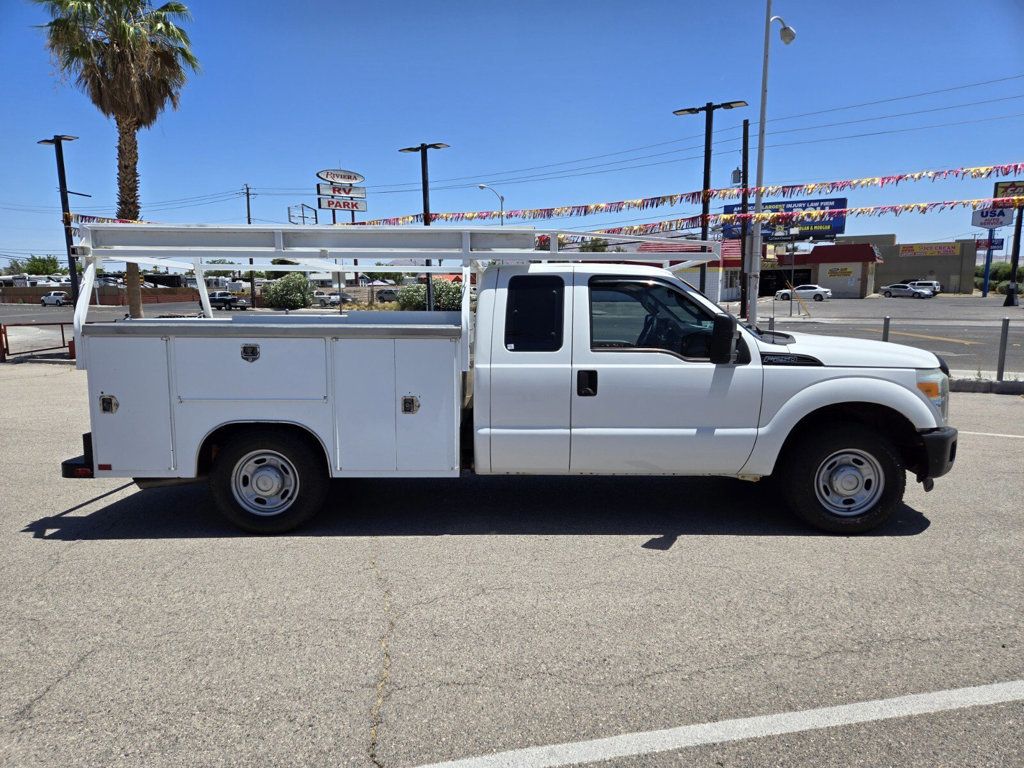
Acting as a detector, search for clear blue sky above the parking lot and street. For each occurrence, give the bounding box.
[0,0,1024,266]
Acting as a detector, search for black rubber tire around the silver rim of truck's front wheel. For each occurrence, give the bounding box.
[776,423,906,534]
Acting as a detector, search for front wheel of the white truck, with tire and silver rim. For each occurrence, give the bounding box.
[779,424,906,534]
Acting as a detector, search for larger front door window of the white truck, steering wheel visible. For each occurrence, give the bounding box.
[590,278,713,359]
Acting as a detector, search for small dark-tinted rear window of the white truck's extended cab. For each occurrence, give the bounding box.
[505,274,565,352]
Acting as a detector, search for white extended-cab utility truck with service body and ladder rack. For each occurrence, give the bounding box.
[62,224,956,532]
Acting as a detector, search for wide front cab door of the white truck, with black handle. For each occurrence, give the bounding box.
[570,270,762,475]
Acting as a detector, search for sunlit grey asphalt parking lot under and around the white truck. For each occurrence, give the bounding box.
[0,364,1024,768]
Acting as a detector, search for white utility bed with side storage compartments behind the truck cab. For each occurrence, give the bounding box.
[81,312,464,477]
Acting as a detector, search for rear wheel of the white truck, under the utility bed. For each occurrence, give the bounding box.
[210,430,329,534]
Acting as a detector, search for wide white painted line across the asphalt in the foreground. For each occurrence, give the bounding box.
[420,680,1024,768]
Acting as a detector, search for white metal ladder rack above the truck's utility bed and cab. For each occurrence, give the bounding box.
[72,223,722,337]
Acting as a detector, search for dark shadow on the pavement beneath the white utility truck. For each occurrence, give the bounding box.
[23,476,931,550]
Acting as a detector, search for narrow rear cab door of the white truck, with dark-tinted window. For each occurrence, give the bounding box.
[476,264,573,474]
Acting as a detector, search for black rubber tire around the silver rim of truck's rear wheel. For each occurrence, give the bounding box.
[209,429,330,534]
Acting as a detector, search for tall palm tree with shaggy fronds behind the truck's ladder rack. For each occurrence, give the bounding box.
[35,0,199,317]
